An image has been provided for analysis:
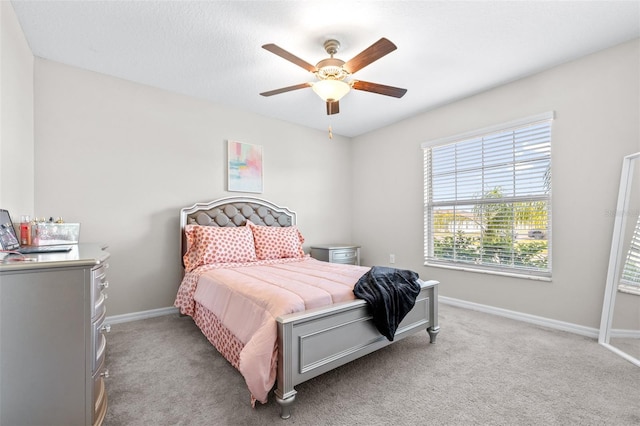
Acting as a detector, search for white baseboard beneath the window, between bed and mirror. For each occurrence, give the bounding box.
[438,296,598,339]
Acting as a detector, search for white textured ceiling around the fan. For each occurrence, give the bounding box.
[12,0,640,137]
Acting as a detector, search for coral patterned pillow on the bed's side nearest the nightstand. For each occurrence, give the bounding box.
[247,221,304,260]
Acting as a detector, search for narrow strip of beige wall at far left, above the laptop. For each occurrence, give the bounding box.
[0,1,34,211]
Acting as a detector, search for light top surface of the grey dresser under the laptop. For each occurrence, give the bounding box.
[0,243,109,273]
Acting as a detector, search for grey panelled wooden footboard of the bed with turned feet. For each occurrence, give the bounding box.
[275,281,439,419]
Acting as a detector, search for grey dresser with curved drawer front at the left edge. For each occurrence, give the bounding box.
[0,244,109,426]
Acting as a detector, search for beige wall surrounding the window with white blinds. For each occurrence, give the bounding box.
[352,40,640,327]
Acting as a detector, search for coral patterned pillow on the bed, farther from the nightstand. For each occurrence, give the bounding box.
[183,225,257,272]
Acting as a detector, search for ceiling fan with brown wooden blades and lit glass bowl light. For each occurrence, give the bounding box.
[260,37,407,115]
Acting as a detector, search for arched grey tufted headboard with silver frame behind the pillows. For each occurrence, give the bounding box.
[180,197,296,255]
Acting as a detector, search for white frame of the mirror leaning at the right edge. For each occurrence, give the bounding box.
[598,152,640,367]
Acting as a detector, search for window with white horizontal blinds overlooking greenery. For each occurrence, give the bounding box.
[422,113,553,277]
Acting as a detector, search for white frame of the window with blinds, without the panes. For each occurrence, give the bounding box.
[421,111,555,281]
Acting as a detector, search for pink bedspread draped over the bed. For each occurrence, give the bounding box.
[175,256,369,403]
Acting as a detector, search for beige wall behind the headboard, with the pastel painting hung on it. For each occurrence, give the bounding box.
[35,59,351,315]
